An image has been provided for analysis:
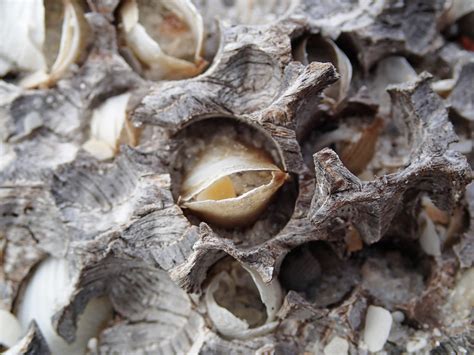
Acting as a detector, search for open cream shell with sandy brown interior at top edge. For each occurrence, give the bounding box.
[119,0,205,80]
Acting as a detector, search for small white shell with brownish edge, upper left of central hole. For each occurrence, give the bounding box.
[83,93,140,160]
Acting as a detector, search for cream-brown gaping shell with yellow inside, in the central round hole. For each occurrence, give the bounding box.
[179,137,289,227]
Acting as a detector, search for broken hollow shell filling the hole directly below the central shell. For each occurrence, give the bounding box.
[205,262,283,339]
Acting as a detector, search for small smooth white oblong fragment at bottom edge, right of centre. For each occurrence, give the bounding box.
[364,306,392,352]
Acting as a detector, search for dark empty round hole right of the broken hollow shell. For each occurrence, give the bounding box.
[278,241,361,307]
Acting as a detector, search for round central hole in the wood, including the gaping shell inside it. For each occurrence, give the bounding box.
[172,117,297,244]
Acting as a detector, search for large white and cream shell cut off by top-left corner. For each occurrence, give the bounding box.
[0,0,88,88]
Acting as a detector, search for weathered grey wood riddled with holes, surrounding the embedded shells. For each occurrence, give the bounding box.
[0,0,474,354]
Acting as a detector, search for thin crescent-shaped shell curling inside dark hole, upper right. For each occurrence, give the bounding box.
[293,35,352,106]
